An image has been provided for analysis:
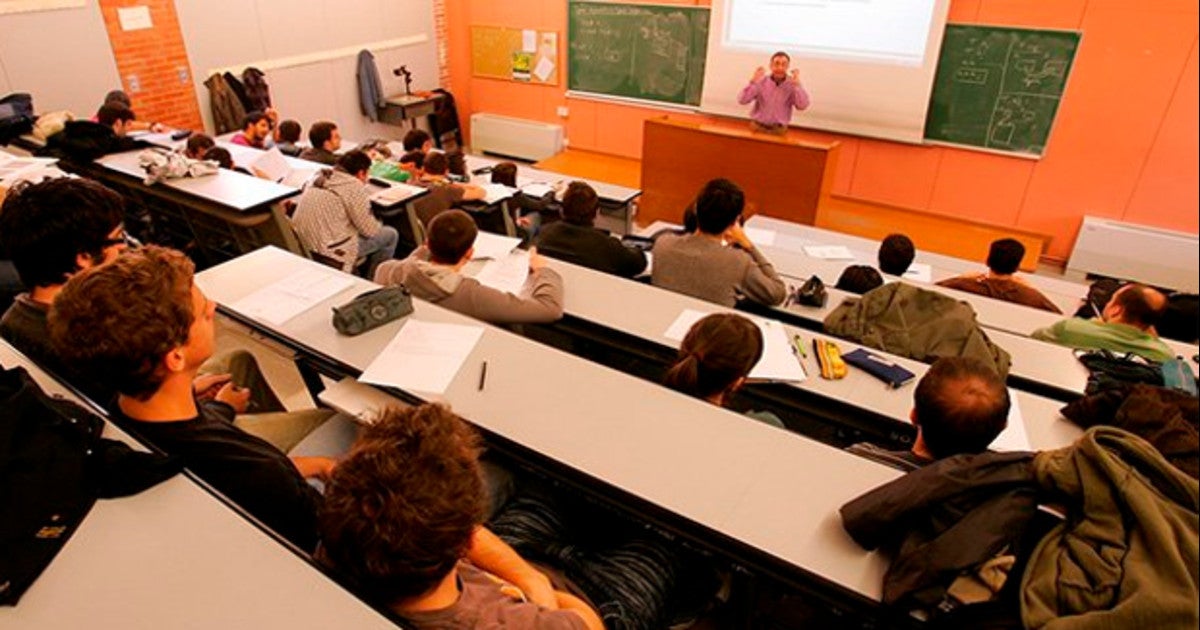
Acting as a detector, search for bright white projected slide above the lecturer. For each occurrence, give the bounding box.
[722,0,935,66]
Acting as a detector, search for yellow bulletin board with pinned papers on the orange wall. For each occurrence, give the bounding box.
[470,25,559,85]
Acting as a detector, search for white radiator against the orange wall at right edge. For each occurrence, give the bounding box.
[1067,216,1200,293]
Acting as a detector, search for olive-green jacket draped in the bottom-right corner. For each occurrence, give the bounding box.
[1021,427,1200,630]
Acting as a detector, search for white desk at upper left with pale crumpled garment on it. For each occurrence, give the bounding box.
[96,150,300,211]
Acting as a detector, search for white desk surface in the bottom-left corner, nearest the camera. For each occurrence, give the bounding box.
[0,342,396,630]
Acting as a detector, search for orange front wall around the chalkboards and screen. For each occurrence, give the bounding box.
[445,0,1200,259]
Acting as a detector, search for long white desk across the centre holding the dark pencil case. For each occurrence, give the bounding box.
[197,247,899,601]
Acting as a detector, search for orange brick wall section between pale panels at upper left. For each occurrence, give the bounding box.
[97,0,204,130]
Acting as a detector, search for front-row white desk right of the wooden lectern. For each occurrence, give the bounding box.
[746,215,1087,314]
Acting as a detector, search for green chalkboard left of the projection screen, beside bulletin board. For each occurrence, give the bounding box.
[566,1,708,106]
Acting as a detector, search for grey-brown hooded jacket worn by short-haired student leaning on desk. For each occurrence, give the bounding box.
[374,245,563,324]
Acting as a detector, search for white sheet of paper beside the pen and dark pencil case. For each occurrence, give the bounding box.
[359,319,484,395]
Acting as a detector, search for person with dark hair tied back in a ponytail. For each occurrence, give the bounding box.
[662,313,784,428]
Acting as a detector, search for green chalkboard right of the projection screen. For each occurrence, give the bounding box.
[925,24,1080,156]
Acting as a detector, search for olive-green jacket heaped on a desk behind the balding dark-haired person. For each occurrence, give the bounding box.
[824,282,1012,377]
